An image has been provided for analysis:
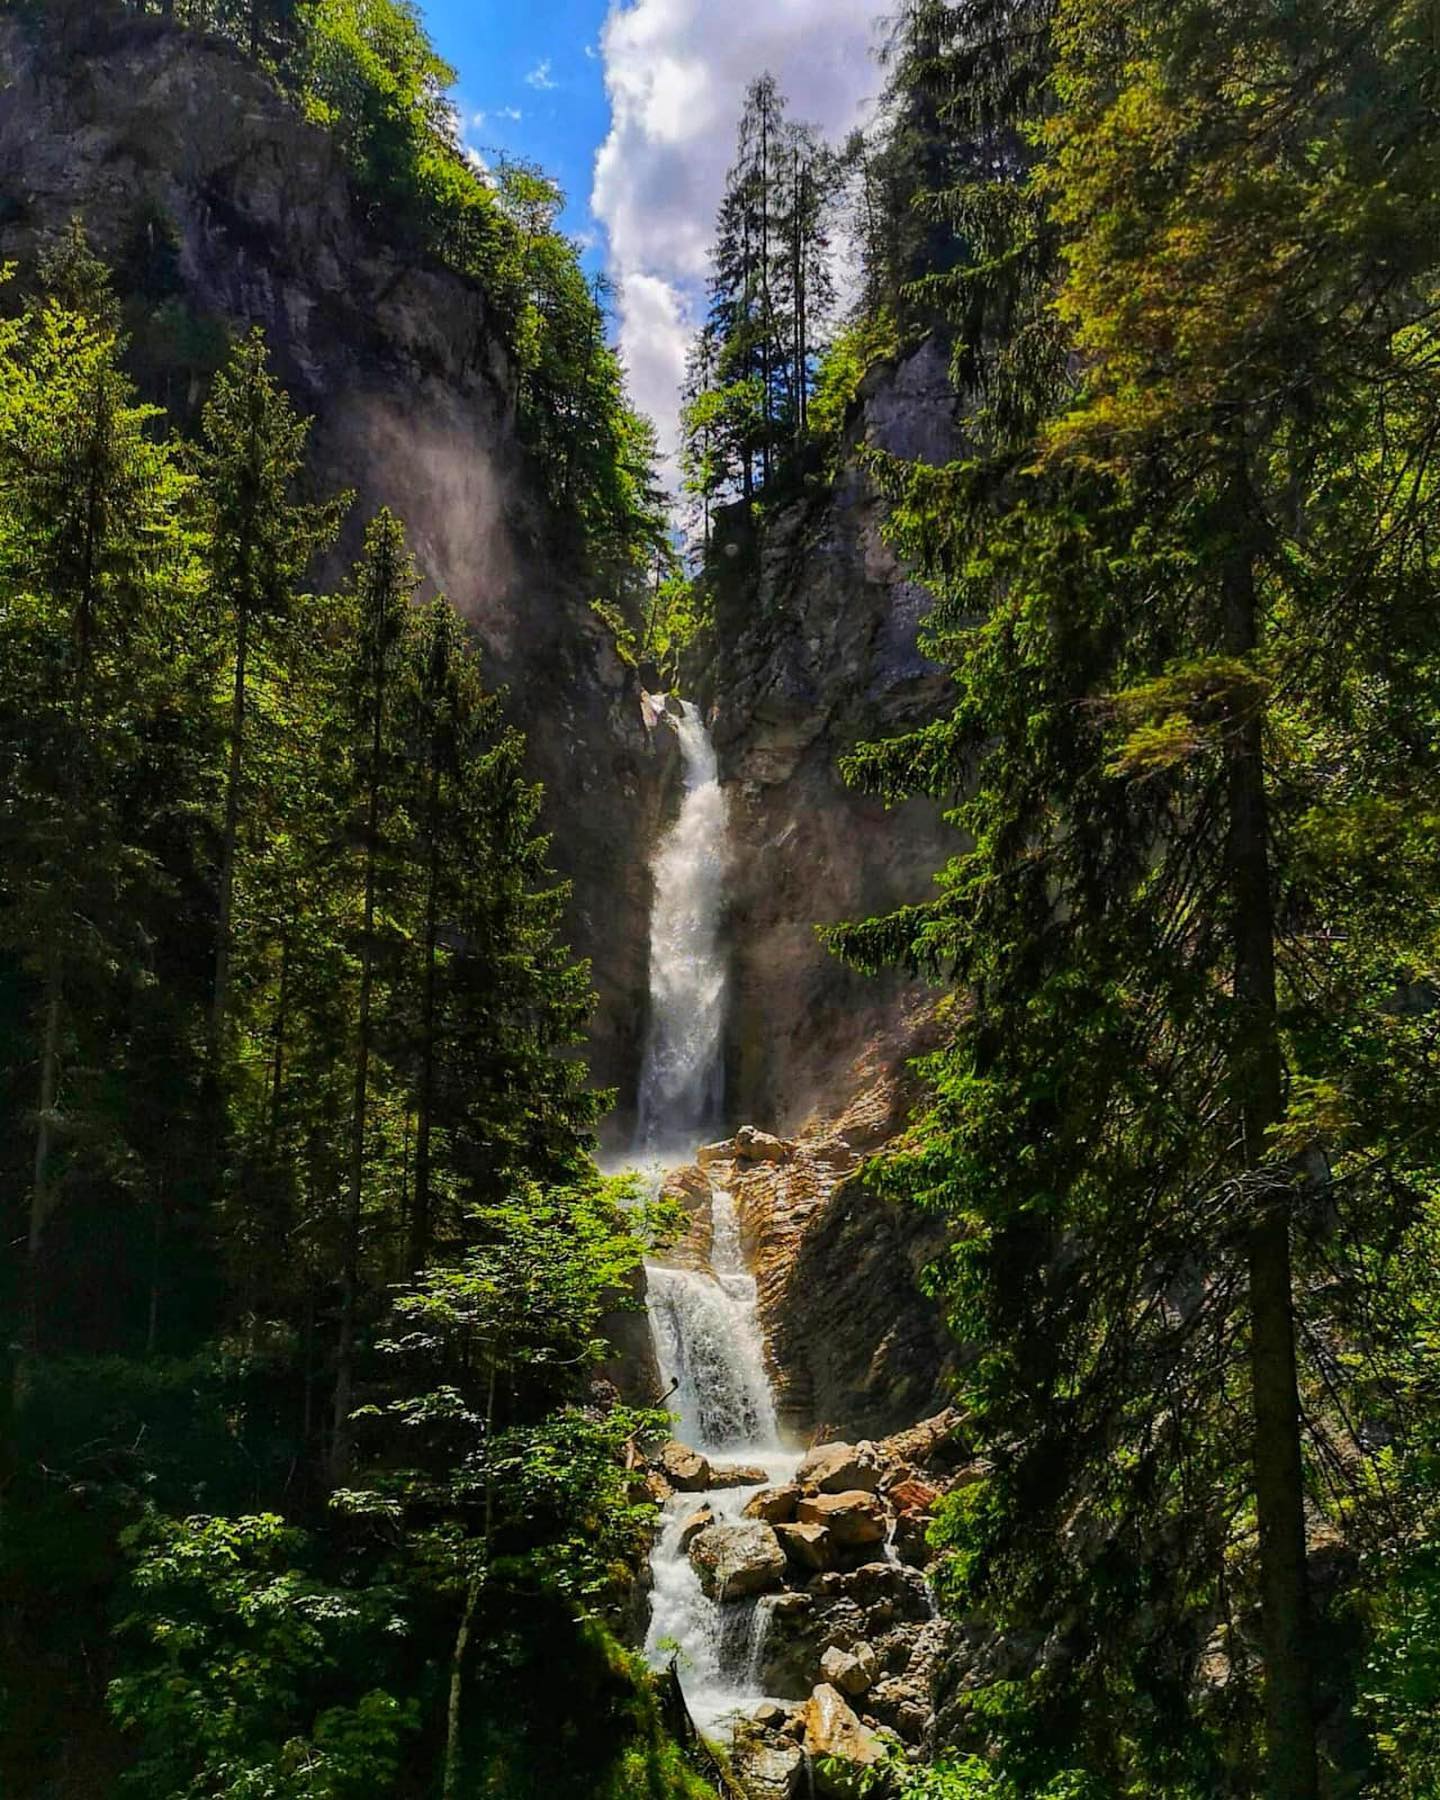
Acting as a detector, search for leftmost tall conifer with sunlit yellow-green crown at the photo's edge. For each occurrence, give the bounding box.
[0,277,189,1375]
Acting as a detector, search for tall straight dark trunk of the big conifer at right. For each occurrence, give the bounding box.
[1224,477,1319,1800]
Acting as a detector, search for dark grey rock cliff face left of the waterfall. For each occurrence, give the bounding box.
[0,18,673,1130]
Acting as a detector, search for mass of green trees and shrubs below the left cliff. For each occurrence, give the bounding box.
[0,261,686,1800]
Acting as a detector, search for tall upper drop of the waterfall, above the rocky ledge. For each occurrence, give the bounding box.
[639,700,725,1157]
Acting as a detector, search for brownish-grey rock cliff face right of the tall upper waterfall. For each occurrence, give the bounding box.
[713,346,954,1130]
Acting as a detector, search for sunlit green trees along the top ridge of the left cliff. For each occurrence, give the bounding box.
[34,0,666,594]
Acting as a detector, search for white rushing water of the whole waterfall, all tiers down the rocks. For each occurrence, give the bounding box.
[637,704,799,1732]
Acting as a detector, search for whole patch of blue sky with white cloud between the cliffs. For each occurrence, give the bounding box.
[421,0,896,479]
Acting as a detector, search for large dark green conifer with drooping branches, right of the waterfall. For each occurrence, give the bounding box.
[837,0,1436,1800]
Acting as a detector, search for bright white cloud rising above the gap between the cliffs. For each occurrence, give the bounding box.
[590,0,893,482]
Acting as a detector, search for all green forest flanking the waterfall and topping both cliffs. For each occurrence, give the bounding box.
[0,0,1440,1800]
